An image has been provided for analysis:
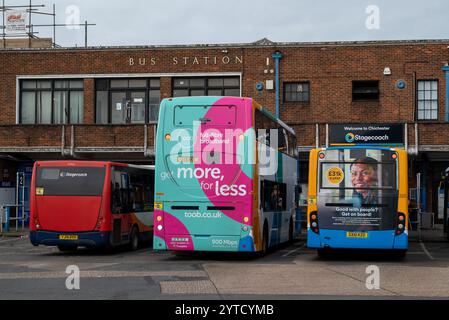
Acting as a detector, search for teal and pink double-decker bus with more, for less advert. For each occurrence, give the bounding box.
[153,96,298,252]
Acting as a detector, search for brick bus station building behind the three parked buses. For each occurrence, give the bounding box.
[0,39,449,221]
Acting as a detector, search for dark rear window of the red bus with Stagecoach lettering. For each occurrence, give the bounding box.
[36,167,106,196]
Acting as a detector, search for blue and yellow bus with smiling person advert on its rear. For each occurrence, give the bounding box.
[307,146,408,256]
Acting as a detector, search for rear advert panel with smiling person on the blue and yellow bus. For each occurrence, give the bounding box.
[317,149,398,231]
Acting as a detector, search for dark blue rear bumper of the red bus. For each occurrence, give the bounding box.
[30,231,110,247]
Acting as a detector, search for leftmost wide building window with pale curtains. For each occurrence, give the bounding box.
[19,79,84,124]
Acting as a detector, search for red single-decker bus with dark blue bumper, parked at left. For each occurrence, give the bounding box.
[30,161,154,251]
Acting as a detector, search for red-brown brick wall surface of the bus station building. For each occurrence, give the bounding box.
[0,42,449,146]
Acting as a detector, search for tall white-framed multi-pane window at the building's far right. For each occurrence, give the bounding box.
[417,80,438,120]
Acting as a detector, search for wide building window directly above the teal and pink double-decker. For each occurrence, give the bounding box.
[172,77,240,97]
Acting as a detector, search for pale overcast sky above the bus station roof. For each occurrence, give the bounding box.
[5,0,449,46]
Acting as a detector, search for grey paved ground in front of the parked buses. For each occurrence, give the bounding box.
[0,230,449,300]
